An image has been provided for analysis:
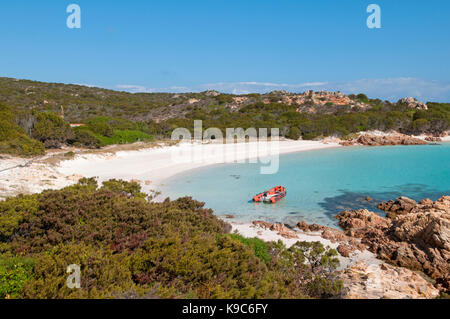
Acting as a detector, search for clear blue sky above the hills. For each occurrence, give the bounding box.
[0,0,450,101]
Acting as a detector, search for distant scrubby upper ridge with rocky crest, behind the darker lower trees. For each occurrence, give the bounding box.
[0,77,434,122]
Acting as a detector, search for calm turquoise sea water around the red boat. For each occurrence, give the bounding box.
[162,143,450,226]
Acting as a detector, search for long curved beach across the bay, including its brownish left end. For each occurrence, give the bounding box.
[0,137,450,200]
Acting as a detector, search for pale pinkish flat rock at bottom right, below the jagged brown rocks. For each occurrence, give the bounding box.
[339,262,439,299]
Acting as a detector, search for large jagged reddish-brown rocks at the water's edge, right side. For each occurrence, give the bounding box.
[336,196,450,289]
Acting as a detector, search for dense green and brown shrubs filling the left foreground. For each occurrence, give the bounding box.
[0,179,342,299]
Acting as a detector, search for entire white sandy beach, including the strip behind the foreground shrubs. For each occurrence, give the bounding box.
[0,141,384,268]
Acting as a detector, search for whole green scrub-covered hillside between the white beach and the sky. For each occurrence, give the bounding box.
[0,78,450,156]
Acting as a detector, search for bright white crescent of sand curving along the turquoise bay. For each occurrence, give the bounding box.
[57,141,340,195]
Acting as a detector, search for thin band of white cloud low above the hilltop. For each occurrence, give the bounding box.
[116,77,450,102]
